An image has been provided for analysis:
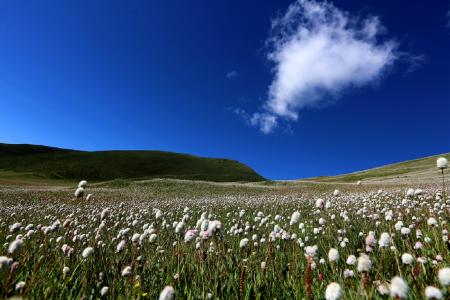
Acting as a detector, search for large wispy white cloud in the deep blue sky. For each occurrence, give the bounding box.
[250,0,398,133]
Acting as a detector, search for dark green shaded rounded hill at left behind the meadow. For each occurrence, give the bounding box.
[0,143,265,182]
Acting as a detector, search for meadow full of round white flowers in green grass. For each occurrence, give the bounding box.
[0,158,450,299]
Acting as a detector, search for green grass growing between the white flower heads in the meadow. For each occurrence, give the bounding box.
[0,179,450,299]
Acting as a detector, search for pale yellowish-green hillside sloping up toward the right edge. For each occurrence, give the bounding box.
[305,153,450,183]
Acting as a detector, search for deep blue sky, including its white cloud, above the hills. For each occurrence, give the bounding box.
[0,0,450,179]
